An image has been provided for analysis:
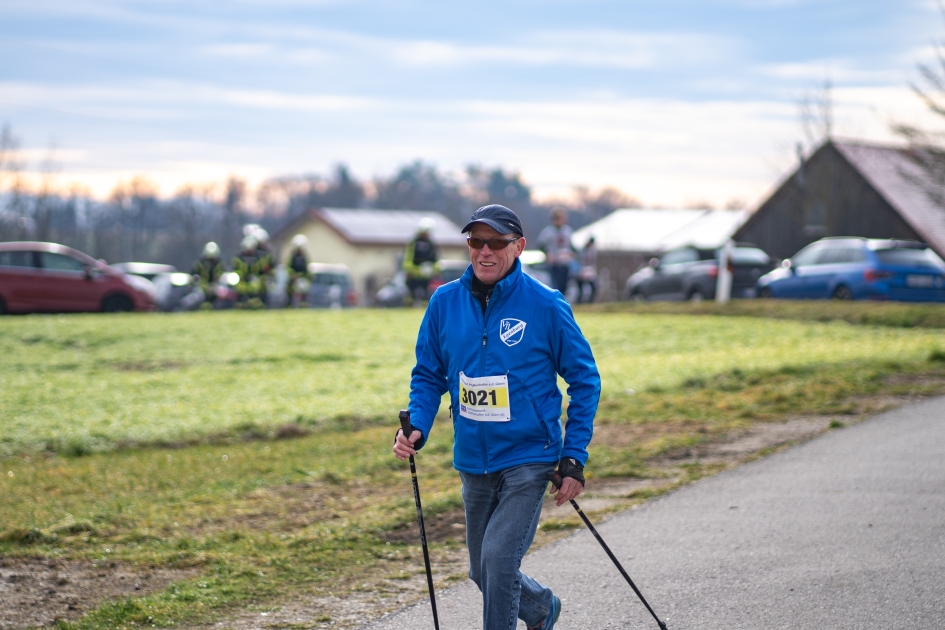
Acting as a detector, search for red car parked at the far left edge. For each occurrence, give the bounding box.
[0,241,154,313]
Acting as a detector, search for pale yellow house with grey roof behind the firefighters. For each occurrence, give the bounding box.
[271,208,469,304]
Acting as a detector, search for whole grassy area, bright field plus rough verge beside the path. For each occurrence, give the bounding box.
[0,305,945,629]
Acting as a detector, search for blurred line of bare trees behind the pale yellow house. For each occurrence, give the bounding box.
[0,125,640,269]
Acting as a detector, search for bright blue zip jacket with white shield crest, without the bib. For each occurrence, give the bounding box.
[409,260,600,474]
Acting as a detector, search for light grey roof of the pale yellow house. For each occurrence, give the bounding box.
[273,208,466,247]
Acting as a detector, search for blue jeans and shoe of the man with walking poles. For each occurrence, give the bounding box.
[459,464,555,630]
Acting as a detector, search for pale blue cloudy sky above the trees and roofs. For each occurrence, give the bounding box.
[0,0,945,207]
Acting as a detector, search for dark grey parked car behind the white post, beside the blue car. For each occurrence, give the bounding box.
[626,243,774,302]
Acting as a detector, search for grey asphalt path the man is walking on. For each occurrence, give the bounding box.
[365,397,945,630]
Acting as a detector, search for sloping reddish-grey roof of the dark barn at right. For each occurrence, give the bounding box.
[832,140,945,255]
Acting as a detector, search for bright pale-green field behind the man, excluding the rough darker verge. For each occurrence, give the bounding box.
[0,310,945,455]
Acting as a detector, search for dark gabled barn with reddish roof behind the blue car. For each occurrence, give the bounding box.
[734,140,945,258]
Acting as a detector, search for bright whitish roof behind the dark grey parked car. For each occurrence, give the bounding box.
[571,208,749,252]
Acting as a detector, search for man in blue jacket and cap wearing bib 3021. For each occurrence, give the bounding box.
[394,205,600,630]
